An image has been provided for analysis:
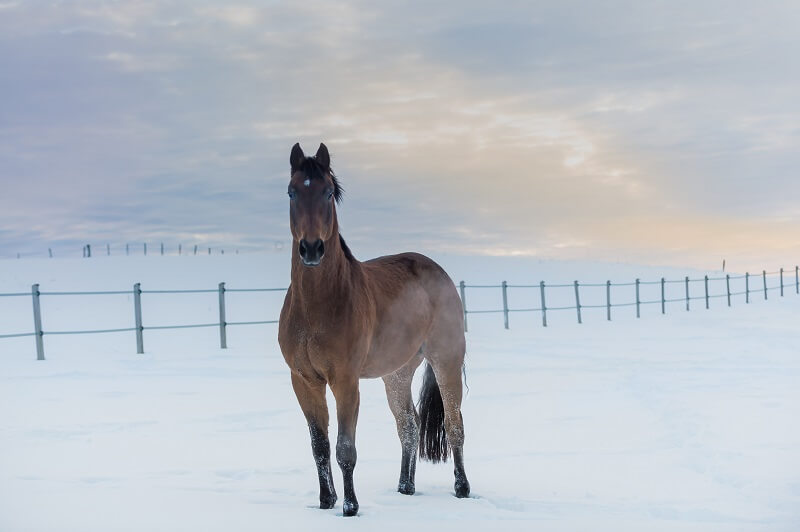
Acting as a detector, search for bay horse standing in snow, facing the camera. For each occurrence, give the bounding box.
[278,143,470,516]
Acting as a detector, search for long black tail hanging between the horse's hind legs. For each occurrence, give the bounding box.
[417,363,448,463]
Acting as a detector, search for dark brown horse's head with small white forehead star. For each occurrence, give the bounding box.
[289,143,342,266]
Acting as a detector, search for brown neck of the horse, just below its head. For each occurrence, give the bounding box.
[292,233,355,303]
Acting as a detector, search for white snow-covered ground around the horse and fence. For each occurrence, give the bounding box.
[0,254,800,532]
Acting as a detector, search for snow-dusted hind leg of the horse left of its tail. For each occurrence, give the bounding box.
[383,355,422,495]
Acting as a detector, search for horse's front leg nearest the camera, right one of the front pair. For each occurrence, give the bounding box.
[331,378,360,516]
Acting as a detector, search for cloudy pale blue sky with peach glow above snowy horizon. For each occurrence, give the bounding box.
[0,0,800,271]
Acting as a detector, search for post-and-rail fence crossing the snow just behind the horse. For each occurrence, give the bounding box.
[0,266,800,360]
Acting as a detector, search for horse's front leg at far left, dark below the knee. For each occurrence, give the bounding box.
[292,372,336,510]
